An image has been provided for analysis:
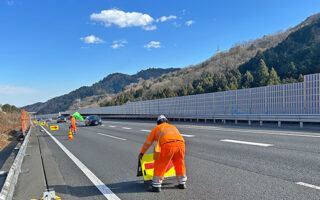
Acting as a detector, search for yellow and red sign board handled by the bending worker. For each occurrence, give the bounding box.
[141,154,176,181]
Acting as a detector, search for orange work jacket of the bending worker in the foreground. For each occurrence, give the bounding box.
[141,123,184,154]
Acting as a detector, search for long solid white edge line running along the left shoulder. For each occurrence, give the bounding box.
[41,127,120,200]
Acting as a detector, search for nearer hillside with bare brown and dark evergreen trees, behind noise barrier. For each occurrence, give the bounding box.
[101,14,320,106]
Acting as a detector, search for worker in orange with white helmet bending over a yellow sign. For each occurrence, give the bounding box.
[139,115,187,192]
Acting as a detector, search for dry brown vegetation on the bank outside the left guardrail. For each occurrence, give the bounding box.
[0,110,21,150]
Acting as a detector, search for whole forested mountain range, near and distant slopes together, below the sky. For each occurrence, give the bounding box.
[26,14,320,113]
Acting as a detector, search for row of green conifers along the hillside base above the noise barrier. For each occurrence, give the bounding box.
[100,59,303,106]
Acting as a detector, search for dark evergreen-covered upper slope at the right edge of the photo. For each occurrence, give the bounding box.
[239,15,320,79]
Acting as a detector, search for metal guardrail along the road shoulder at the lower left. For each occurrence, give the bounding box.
[0,126,32,200]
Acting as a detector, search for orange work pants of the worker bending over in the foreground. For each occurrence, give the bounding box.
[154,142,186,179]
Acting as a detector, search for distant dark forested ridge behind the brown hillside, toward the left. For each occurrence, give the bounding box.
[23,68,178,114]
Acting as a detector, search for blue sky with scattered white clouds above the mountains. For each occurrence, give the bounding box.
[0,0,320,106]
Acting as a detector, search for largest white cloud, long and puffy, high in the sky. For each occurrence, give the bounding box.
[90,8,156,30]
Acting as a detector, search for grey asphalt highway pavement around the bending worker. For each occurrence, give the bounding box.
[13,120,320,200]
